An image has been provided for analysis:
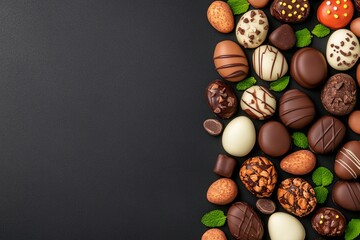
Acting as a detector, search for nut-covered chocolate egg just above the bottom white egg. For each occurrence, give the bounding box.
[277,178,317,217]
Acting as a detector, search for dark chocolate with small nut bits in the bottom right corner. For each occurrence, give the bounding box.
[311,207,346,237]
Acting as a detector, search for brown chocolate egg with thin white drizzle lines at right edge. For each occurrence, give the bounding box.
[334,141,360,180]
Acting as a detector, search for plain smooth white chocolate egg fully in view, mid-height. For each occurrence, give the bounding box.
[222,116,256,157]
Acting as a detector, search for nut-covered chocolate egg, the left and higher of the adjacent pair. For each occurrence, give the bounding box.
[239,157,277,198]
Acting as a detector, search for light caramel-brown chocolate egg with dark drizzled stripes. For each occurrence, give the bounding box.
[214,40,249,82]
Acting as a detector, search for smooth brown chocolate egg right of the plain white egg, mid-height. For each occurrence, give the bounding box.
[258,121,291,157]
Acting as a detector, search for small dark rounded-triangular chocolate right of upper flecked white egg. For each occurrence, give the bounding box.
[269,24,296,51]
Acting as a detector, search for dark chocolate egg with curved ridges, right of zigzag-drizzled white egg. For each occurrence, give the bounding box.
[279,89,316,129]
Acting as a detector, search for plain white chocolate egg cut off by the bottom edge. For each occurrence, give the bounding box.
[268,212,306,240]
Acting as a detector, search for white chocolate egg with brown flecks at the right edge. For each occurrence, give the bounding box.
[326,29,360,71]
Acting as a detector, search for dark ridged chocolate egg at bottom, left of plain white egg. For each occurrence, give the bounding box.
[226,202,264,240]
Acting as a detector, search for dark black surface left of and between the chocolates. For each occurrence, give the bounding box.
[0,0,359,240]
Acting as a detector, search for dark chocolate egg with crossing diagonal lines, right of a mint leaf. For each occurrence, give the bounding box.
[307,115,346,154]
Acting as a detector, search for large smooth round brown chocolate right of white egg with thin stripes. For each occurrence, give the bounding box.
[290,47,328,89]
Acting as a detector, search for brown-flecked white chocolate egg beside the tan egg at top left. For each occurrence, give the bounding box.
[236,10,269,48]
